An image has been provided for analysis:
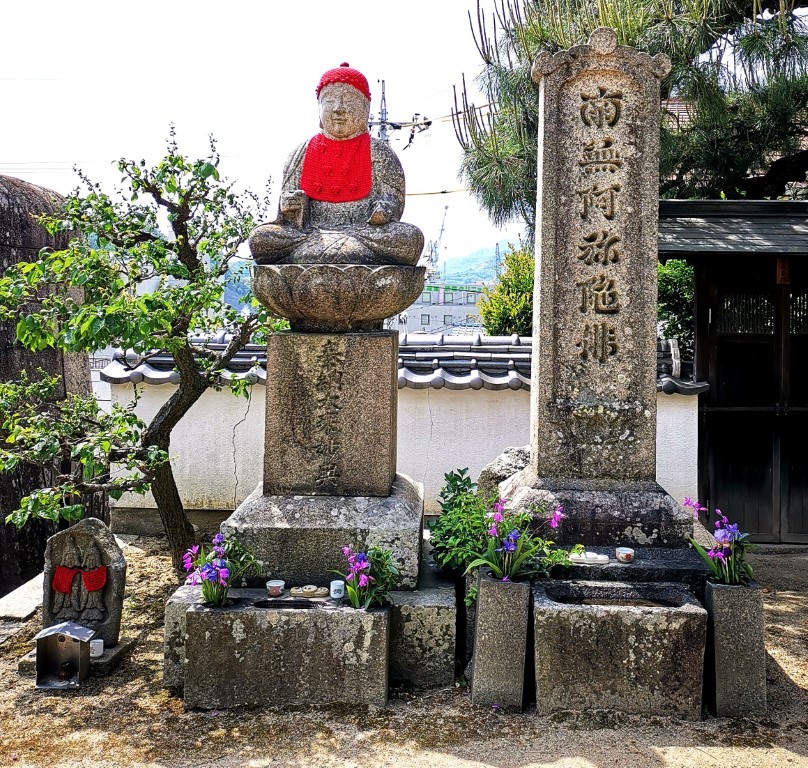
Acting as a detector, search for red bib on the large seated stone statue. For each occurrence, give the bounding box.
[300,133,373,203]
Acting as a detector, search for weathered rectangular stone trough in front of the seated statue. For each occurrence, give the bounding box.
[184,590,390,709]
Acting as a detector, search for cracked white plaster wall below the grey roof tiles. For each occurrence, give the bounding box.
[112,384,698,512]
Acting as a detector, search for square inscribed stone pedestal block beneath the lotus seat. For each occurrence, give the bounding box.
[263,331,398,496]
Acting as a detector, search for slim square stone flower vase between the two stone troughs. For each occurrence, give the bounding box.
[471,570,530,709]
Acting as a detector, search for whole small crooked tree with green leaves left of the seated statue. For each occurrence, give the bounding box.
[0,130,278,565]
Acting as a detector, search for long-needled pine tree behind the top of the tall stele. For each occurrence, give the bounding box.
[454,0,808,241]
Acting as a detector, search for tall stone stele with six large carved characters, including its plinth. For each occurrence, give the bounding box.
[505,28,690,546]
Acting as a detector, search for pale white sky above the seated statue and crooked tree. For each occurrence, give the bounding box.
[0,0,521,258]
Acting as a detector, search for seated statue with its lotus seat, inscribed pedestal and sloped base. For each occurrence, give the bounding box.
[222,64,425,589]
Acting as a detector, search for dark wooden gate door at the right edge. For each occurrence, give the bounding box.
[697,256,808,542]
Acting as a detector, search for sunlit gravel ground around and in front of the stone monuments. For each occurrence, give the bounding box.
[0,538,808,768]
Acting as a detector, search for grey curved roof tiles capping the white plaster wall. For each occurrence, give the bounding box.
[101,334,707,395]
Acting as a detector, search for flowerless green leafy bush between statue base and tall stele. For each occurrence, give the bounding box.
[429,469,491,573]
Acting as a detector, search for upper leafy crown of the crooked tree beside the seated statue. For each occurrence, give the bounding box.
[0,132,274,356]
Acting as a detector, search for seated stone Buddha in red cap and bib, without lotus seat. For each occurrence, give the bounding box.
[250,63,424,266]
